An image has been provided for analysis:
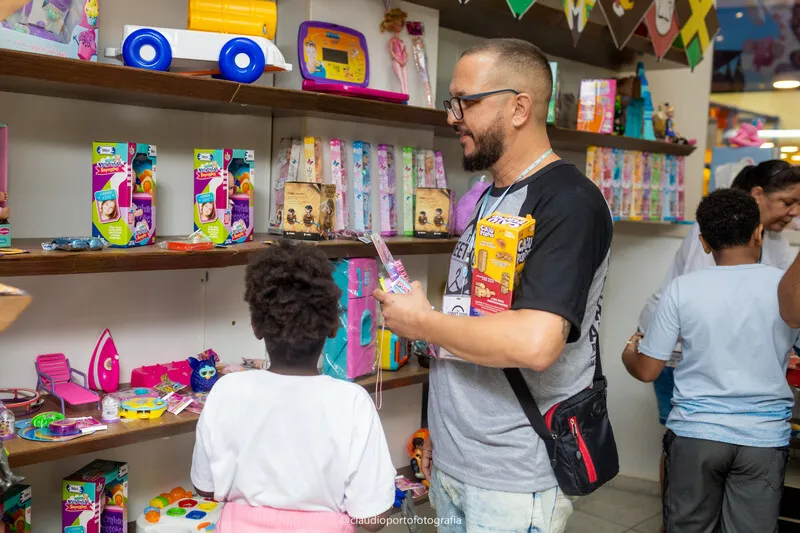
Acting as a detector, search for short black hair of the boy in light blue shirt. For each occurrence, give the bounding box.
[697,189,761,251]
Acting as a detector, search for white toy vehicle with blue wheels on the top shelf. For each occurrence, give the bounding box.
[105,26,292,83]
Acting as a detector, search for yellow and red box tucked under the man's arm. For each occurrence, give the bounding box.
[470,213,536,316]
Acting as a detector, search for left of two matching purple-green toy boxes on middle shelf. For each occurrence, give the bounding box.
[92,142,156,248]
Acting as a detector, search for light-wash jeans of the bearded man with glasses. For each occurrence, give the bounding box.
[430,468,572,533]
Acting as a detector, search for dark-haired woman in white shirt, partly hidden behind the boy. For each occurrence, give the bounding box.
[624,159,800,528]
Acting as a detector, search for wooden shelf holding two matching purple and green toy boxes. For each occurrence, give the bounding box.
[0,234,458,277]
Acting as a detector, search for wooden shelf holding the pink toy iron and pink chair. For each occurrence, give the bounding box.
[3,363,428,468]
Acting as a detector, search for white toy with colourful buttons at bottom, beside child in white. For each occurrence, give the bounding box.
[136,487,225,533]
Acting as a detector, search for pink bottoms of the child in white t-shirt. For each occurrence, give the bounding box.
[217,503,357,533]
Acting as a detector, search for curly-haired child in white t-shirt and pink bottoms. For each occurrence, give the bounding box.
[191,240,396,533]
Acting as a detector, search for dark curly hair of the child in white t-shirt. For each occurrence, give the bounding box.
[244,239,341,366]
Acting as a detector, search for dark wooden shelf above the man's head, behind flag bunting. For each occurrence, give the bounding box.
[409,0,689,70]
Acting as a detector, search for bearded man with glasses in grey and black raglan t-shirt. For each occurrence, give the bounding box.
[375,39,612,533]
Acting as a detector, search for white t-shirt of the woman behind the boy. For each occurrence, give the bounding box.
[639,223,797,366]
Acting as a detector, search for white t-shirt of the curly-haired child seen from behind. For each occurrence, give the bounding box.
[192,370,397,518]
